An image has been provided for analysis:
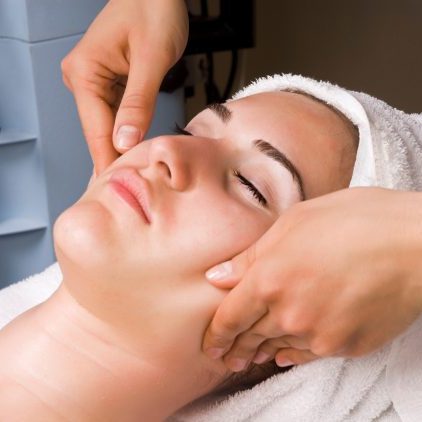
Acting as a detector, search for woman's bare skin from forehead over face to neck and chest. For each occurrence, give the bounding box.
[0,92,354,422]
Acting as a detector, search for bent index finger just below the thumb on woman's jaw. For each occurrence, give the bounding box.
[203,279,267,359]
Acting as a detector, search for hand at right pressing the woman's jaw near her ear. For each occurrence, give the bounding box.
[203,188,422,371]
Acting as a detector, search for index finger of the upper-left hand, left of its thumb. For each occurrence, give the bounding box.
[74,89,120,175]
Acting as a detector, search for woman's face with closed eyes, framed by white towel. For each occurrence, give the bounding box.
[55,92,354,283]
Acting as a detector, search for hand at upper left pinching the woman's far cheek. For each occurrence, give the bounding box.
[62,0,188,174]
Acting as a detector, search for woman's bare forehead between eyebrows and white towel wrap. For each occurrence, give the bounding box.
[192,91,352,198]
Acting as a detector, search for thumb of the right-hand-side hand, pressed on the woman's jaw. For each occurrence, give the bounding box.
[205,244,256,289]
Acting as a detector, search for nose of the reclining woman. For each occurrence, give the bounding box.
[149,136,193,191]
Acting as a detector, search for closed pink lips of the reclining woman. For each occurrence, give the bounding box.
[108,167,151,224]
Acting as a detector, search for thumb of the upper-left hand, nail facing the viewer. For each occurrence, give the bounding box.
[113,47,167,152]
